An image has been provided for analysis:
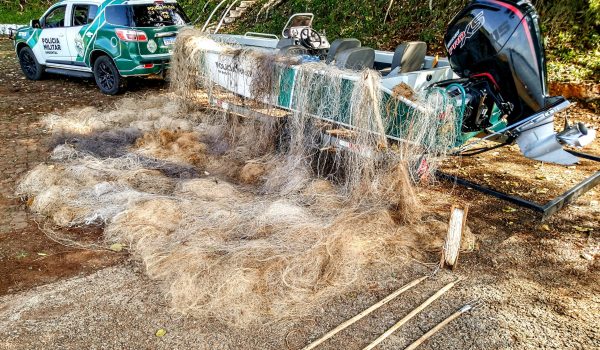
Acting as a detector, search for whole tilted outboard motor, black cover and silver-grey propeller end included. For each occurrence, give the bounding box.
[444,0,595,164]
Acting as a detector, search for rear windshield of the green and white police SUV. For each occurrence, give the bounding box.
[131,3,190,27]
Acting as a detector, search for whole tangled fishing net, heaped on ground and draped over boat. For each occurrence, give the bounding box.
[12,30,464,327]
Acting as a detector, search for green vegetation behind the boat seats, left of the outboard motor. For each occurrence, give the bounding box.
[229,0,468,53]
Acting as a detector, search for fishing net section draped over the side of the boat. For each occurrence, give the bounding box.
[171,30,459,185]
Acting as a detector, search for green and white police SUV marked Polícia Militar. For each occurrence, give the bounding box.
[12,0,190,95]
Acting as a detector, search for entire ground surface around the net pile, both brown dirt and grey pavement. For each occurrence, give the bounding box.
[0,39,600,349]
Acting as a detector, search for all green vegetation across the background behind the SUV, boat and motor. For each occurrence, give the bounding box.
[0,0,600,82]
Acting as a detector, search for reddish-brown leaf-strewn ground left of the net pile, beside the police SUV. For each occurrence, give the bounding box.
[0,37,170,294]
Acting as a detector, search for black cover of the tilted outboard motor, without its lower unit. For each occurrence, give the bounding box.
[444,0,549,124]
